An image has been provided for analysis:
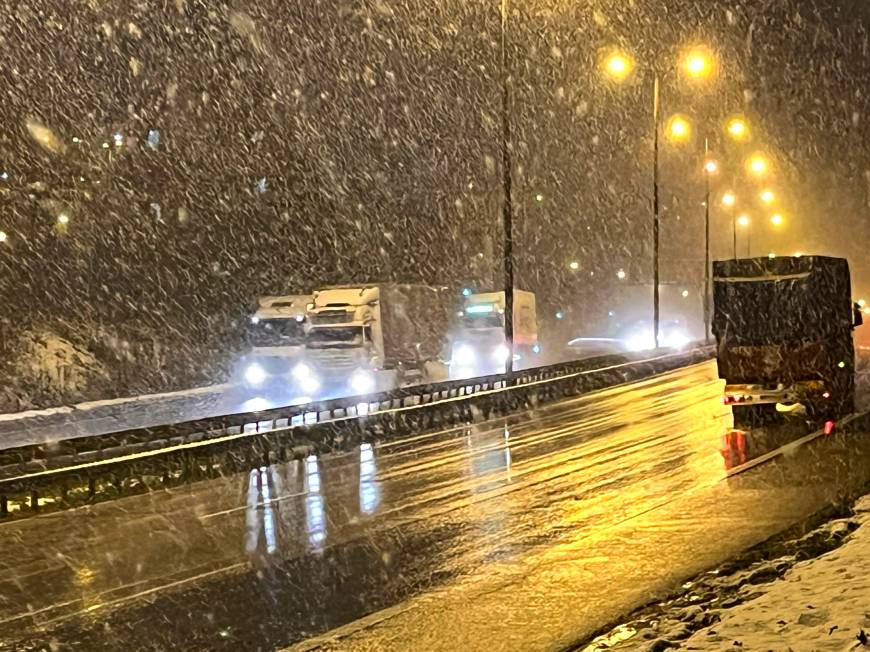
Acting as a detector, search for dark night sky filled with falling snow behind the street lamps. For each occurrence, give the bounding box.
[0,0,870,374]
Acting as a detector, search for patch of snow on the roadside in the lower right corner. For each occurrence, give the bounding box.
[674,496,870,652]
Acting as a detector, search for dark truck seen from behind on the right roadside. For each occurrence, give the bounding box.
[713,256,860,416]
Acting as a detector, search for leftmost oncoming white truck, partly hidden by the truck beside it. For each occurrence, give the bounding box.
[236,294,312,391]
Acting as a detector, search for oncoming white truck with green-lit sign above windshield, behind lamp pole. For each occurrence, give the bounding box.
[450,290,541,378]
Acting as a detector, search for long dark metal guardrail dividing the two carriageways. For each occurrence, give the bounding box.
[0,348,712,517]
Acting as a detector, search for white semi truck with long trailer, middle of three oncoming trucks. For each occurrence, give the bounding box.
[294,283,456,397]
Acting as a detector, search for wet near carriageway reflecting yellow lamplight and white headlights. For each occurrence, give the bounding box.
[0,363,870,650]
